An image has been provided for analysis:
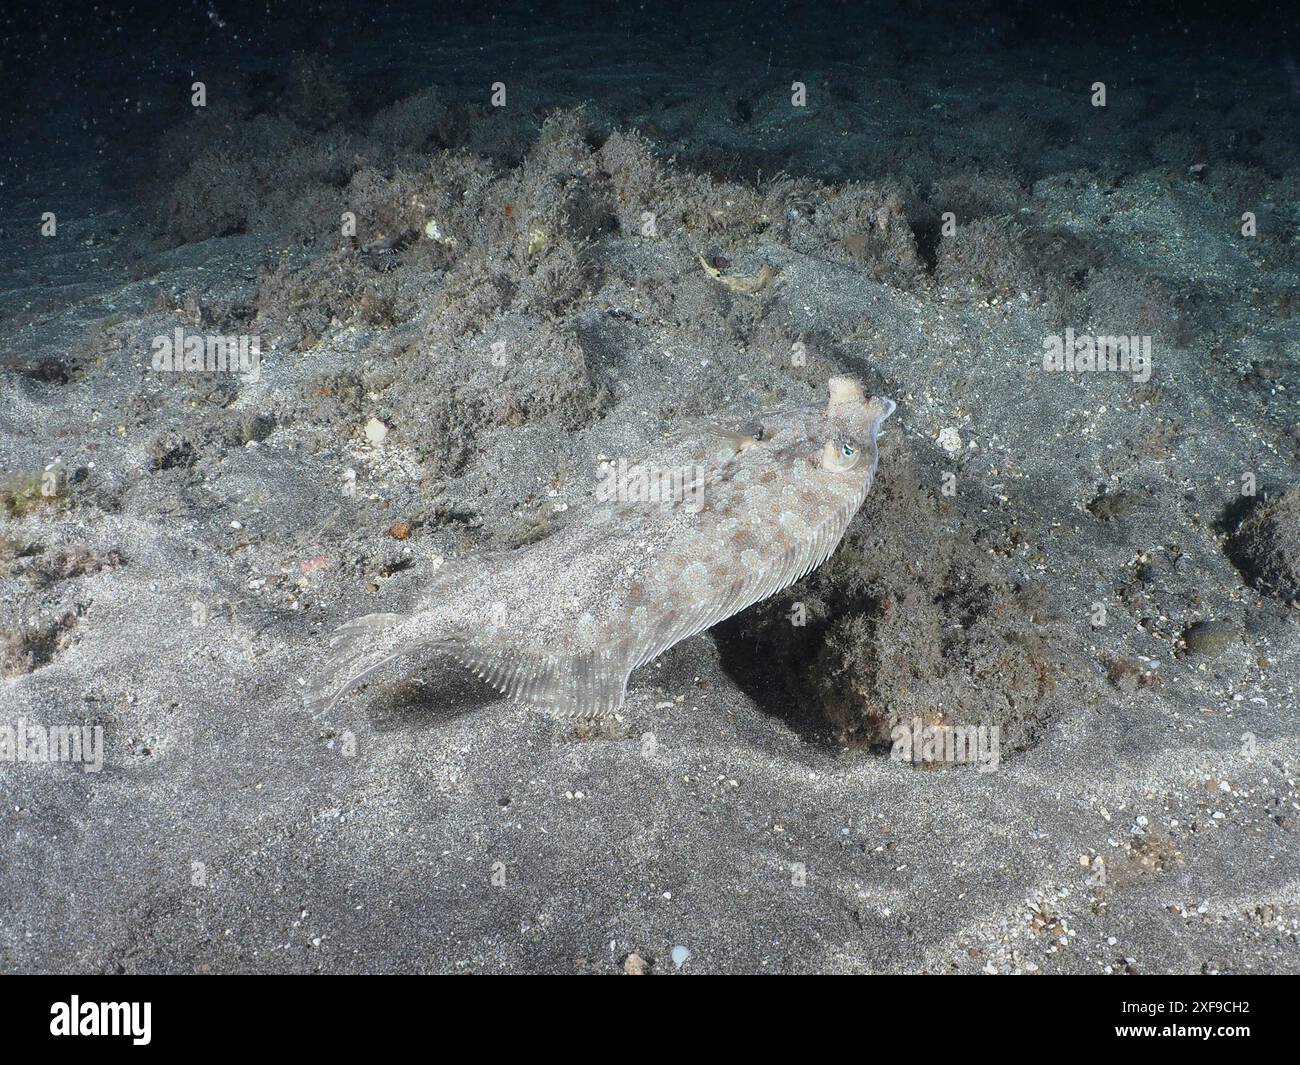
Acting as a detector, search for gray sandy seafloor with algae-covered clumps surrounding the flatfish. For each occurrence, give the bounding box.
[0,7,1300,974]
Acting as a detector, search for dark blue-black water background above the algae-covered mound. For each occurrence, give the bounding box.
[0,0,1300,208]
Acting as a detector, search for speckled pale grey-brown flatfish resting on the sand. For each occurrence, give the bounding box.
[307,377,894,715]
